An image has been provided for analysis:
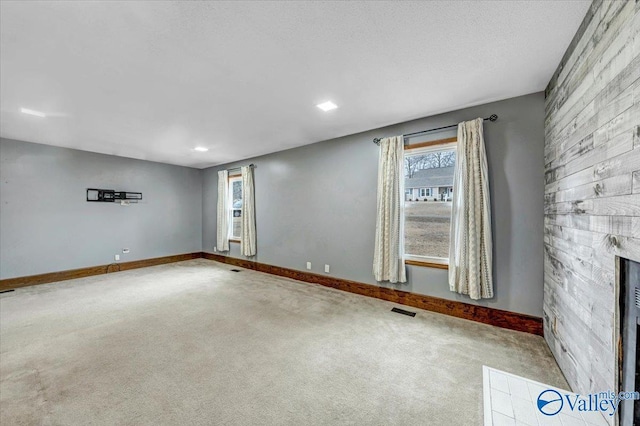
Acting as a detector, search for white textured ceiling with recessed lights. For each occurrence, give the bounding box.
[0,1,590,168]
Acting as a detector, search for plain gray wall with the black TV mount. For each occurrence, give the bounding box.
[0,139,202,278]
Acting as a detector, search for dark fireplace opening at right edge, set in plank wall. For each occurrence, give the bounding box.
[618,258,640,426]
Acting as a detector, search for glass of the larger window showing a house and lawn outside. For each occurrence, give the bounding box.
[404,139,456,265]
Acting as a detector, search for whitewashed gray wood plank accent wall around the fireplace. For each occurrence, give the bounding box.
[544,0,640,393]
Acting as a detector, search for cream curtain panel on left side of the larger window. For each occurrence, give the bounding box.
[373,136,407,283]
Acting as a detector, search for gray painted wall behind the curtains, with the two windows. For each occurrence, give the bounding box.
[202,93,544,316]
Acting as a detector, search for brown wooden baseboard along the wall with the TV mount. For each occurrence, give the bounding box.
[0,252,202,291]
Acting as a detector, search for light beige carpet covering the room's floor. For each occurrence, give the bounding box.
[0,259,567,425]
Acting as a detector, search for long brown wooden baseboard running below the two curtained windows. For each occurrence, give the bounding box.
[202,253,543,336]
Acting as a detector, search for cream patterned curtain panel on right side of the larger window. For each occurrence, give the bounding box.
[449,118,493,299]
